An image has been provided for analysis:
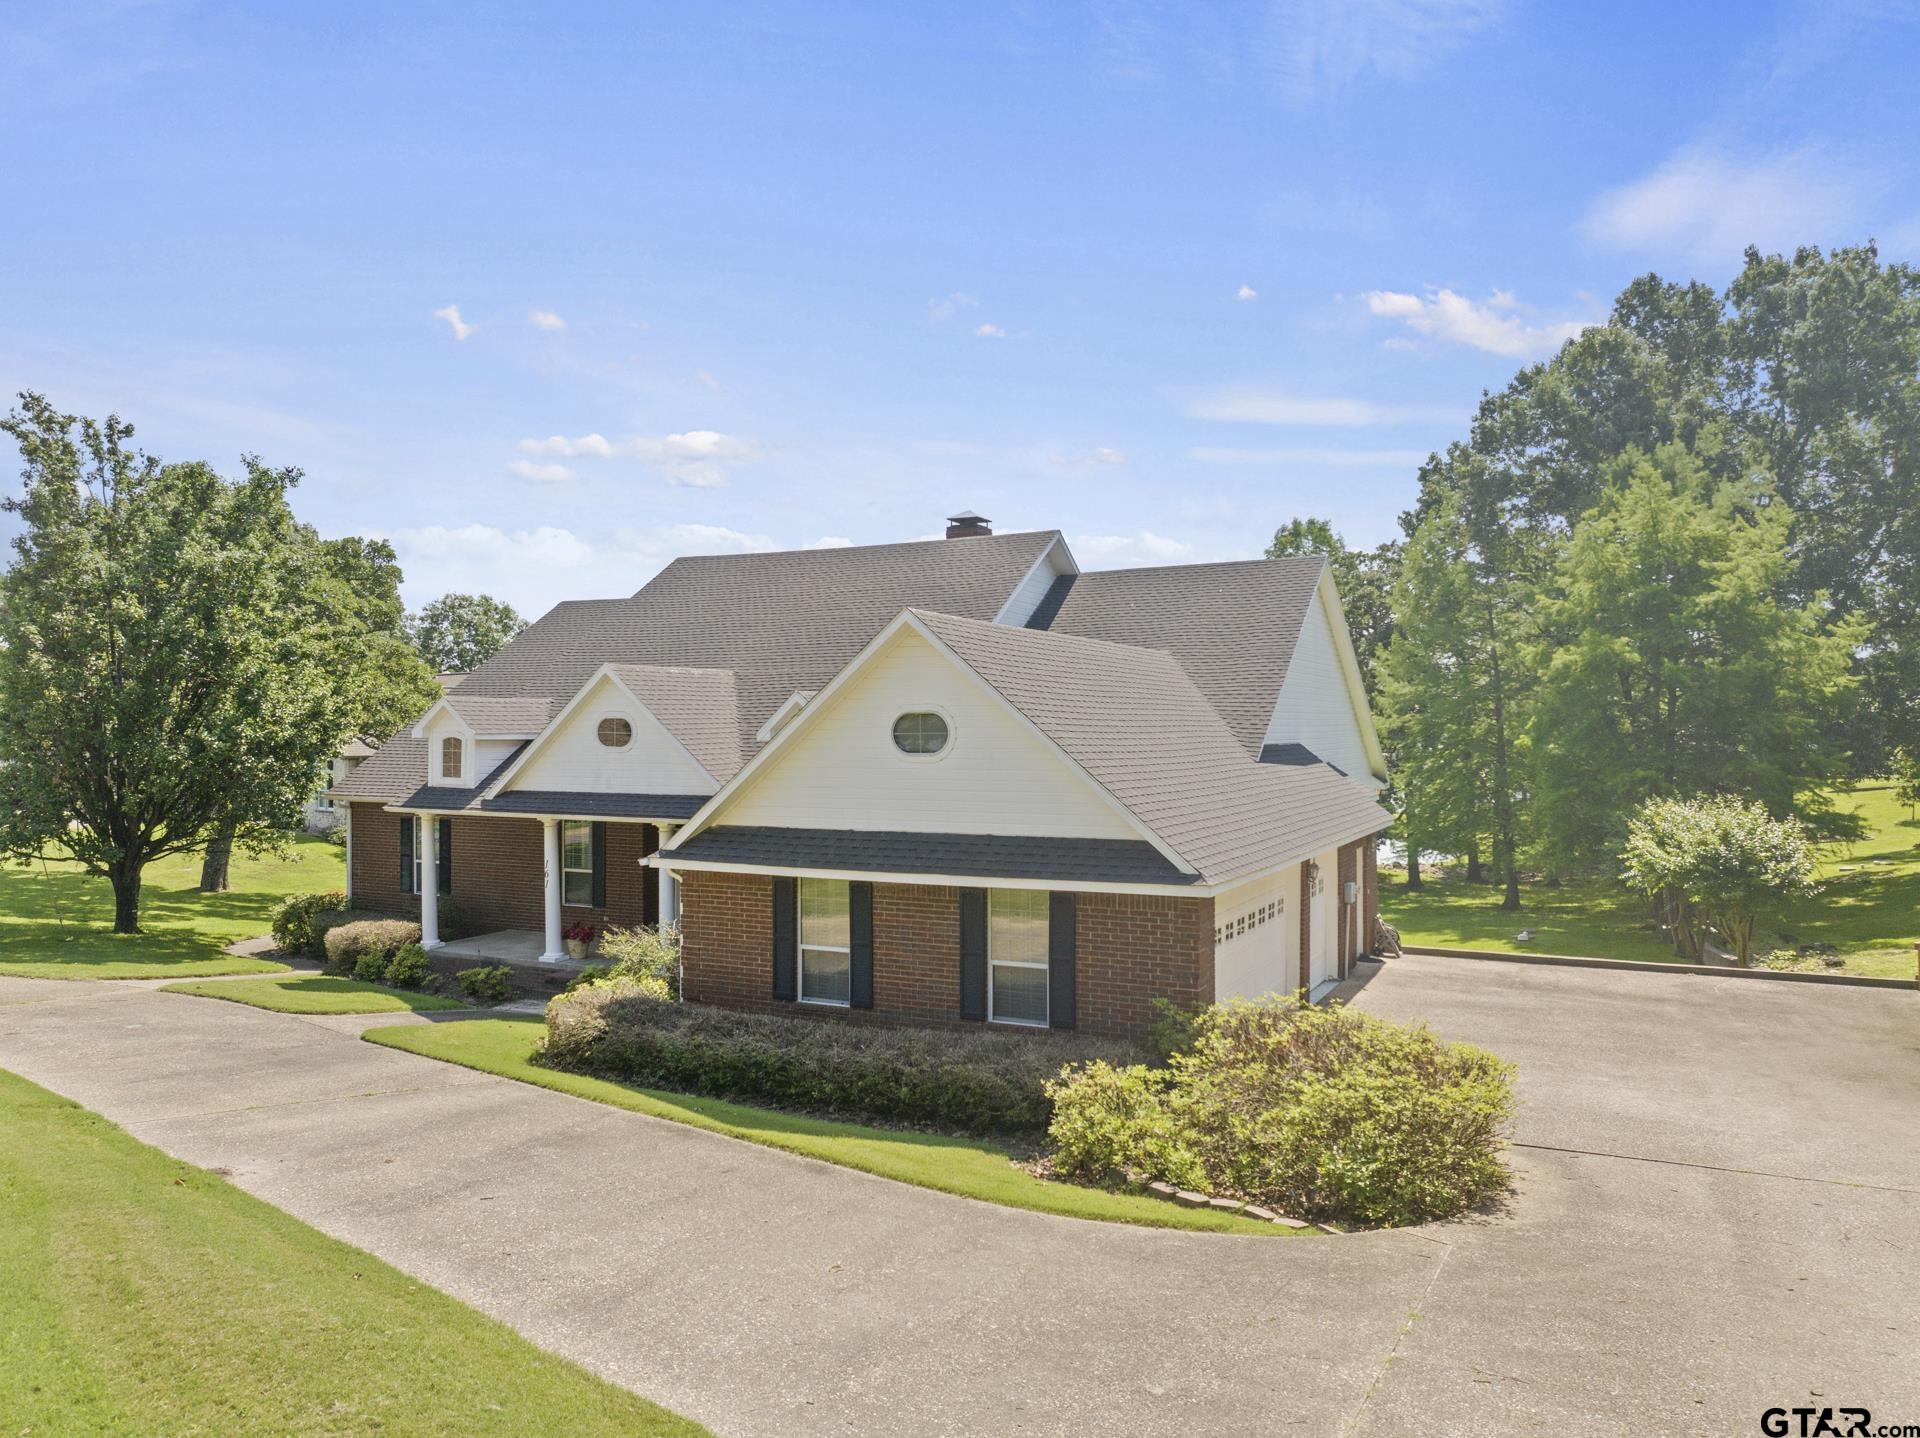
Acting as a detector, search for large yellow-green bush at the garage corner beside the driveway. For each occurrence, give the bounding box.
[1048,1000,1513,1225]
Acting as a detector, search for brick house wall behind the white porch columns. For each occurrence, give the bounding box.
[353,804,660,931]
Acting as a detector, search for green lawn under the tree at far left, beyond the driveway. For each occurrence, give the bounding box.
[0,835,346,979]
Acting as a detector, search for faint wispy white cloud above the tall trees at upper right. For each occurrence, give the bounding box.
[1582,144,1880,265]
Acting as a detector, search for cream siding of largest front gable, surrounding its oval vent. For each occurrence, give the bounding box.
[714,622,1140,839]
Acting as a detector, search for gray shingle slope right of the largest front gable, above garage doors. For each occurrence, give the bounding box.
[916,611,1392,883]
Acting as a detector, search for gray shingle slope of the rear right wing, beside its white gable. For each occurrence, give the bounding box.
[1027,555,1327,758]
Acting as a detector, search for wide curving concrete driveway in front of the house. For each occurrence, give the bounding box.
[0,958,1920,1436]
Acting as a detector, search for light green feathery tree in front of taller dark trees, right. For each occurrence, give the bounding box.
[1530,443,1864,866]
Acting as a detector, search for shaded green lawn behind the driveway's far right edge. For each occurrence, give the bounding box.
[1380,783,1920,979]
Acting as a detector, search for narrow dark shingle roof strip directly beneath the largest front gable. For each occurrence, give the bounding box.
[664,826,1196,885]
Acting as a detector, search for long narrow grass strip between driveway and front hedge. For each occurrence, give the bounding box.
[361,1016,1294,1236]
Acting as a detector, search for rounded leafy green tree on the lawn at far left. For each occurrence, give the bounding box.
[0,394,374,933]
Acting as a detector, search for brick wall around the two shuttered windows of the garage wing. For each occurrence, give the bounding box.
[680,872,1213,1037]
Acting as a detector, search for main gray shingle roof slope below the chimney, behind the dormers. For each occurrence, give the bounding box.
[336,530,1058,803]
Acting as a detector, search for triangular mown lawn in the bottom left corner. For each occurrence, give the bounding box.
[0,1073,705,1438]
